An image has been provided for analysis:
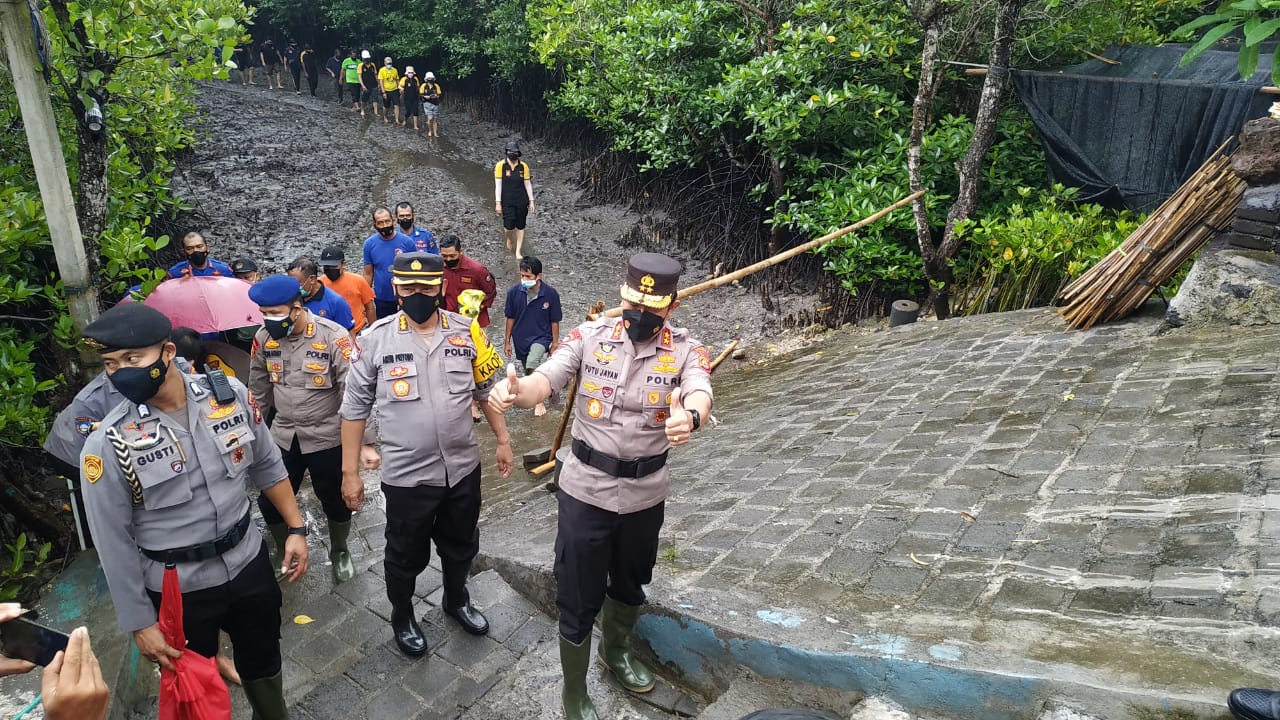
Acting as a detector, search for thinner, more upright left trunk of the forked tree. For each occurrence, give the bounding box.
[906,0,950,316]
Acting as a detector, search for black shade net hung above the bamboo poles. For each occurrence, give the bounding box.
[1012,45,1280,213]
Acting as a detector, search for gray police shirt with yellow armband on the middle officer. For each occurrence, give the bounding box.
[340,310,503,487]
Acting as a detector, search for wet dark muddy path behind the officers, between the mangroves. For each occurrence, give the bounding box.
[174,83,814,357]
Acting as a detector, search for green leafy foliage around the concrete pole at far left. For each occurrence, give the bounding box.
[0,0,251,447]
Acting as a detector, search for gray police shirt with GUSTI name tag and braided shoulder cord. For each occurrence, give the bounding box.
[81,370,285,633]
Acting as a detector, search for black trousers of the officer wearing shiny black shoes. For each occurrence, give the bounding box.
[383,465,480,611]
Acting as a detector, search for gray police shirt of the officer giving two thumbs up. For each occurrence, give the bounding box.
[534,318,712,514]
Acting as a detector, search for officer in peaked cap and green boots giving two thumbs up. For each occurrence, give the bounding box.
[489,252,712,720]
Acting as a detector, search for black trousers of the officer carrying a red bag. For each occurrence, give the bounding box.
[147,543,282,680]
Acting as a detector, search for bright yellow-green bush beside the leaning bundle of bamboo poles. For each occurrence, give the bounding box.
[954,184,1140,315]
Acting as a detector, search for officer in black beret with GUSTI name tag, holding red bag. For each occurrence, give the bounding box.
[79,304,307,720]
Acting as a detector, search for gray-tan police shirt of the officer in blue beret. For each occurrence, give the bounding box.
[248,314,356,452]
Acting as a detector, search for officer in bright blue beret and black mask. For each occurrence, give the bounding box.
[248,275,355,583]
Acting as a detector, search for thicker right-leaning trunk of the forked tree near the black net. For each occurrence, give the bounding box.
[932,0,1028,320]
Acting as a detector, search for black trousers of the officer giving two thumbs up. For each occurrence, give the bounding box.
[556,491,666,644]
